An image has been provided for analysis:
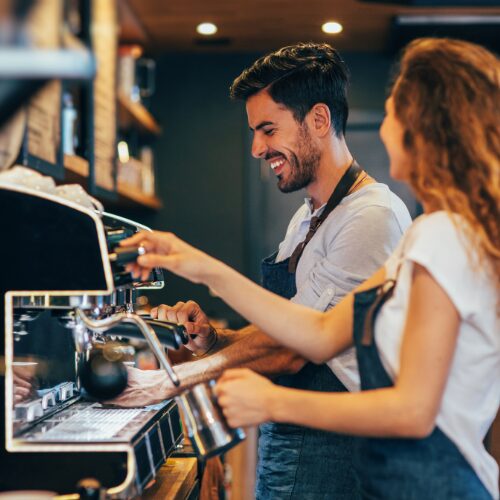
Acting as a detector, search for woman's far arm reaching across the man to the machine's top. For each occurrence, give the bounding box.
[122,232,385,363]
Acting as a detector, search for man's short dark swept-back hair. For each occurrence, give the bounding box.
[230,42,349,137]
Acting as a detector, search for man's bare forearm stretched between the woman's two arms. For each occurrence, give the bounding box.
[171,325,305,394]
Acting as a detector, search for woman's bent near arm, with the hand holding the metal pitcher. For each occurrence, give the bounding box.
[217,264,460,437]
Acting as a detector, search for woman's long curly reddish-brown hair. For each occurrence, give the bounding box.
[392,38,500,289]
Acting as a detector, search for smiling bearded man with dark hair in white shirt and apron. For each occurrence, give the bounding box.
[113,43,411,500]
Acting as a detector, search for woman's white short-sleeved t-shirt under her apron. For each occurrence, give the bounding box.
[375,211,500,498]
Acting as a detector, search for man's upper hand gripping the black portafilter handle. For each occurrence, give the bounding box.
[150,300,217,356]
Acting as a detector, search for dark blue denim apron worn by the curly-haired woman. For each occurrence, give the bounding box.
[353,280,492,500]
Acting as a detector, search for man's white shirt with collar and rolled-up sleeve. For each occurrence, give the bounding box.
[276,183,411,391]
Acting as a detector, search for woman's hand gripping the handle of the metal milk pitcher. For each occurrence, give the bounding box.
[215,368,279,427]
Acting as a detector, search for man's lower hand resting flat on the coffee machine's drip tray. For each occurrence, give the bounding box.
[106,367,179,408]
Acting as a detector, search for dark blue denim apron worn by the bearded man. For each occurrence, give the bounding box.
[256,253,359,500]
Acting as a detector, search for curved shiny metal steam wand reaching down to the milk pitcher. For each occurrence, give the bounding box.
[75,308,180,387]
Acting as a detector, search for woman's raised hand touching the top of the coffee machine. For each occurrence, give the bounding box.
[120,231,218,283]
